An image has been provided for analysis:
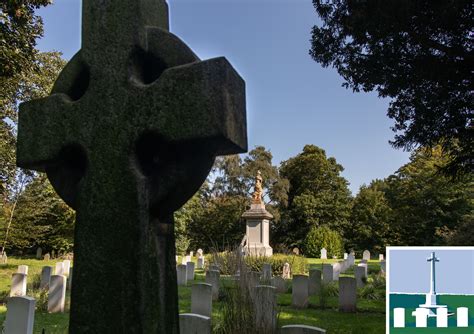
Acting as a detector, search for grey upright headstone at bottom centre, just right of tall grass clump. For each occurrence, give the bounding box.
[253,285,277,333]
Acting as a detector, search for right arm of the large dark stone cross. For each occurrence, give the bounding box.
[143,57,247,155]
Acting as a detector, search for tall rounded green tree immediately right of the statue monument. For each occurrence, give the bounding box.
[280,145,351,246]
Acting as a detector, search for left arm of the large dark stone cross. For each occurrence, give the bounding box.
[17,94,78,171]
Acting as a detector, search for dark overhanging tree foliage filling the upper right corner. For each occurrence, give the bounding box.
[310,0,474,174]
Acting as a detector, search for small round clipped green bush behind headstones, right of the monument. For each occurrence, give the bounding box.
[304,226,344,258]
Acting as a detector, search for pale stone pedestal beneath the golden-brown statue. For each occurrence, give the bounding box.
[242,203,273,256]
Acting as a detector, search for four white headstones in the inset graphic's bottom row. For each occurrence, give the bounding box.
[393,307,469,328]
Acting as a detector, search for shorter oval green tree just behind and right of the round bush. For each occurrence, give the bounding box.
[346,181,392,253]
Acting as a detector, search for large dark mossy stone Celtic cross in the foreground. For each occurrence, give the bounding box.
[17,0,247,334]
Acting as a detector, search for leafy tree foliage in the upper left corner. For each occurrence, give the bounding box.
[0,0,52,78]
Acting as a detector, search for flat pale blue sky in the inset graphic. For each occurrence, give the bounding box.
[388,247,474,294]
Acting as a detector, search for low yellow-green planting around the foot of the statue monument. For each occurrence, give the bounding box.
[207,251,307,276]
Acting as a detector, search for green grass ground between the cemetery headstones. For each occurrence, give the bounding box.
[0,257,385,334]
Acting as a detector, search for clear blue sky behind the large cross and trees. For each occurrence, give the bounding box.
[38,0,409,194]
